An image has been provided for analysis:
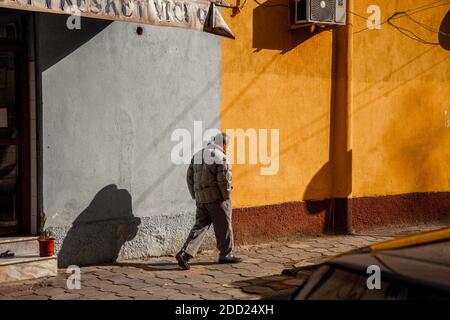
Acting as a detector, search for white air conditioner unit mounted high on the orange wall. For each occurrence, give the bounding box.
[289,0,347,28]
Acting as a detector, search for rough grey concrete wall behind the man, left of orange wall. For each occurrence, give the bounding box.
[38,15,221,265]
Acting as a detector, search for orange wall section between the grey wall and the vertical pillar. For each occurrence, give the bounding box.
[221,0,332,207]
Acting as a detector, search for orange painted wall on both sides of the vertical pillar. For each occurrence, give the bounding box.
[221,0,450,207]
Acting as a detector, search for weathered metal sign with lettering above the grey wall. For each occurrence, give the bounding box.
[0,0,233,38]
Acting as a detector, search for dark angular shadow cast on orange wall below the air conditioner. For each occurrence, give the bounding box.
[253,0,327,54]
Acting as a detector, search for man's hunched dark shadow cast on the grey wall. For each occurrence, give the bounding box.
[58,184,141,267]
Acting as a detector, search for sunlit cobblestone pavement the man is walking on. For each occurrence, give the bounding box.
[0,225,443,300]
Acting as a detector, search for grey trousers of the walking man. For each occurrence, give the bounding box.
[183,200,233,259]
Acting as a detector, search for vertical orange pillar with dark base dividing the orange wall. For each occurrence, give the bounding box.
[327,0,353,234]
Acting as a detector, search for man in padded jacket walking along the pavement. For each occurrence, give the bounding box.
[176,133,242,270]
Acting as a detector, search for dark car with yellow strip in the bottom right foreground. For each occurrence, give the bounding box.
[291,228,450,300]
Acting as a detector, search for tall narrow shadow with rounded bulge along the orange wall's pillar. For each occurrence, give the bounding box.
[303,28,353,233]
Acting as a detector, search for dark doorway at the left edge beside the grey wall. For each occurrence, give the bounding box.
[0,10,30,235]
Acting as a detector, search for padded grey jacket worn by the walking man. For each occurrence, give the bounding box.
[187,143,232,203]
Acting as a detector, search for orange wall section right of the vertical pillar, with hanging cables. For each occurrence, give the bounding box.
[352,0,450,196]
